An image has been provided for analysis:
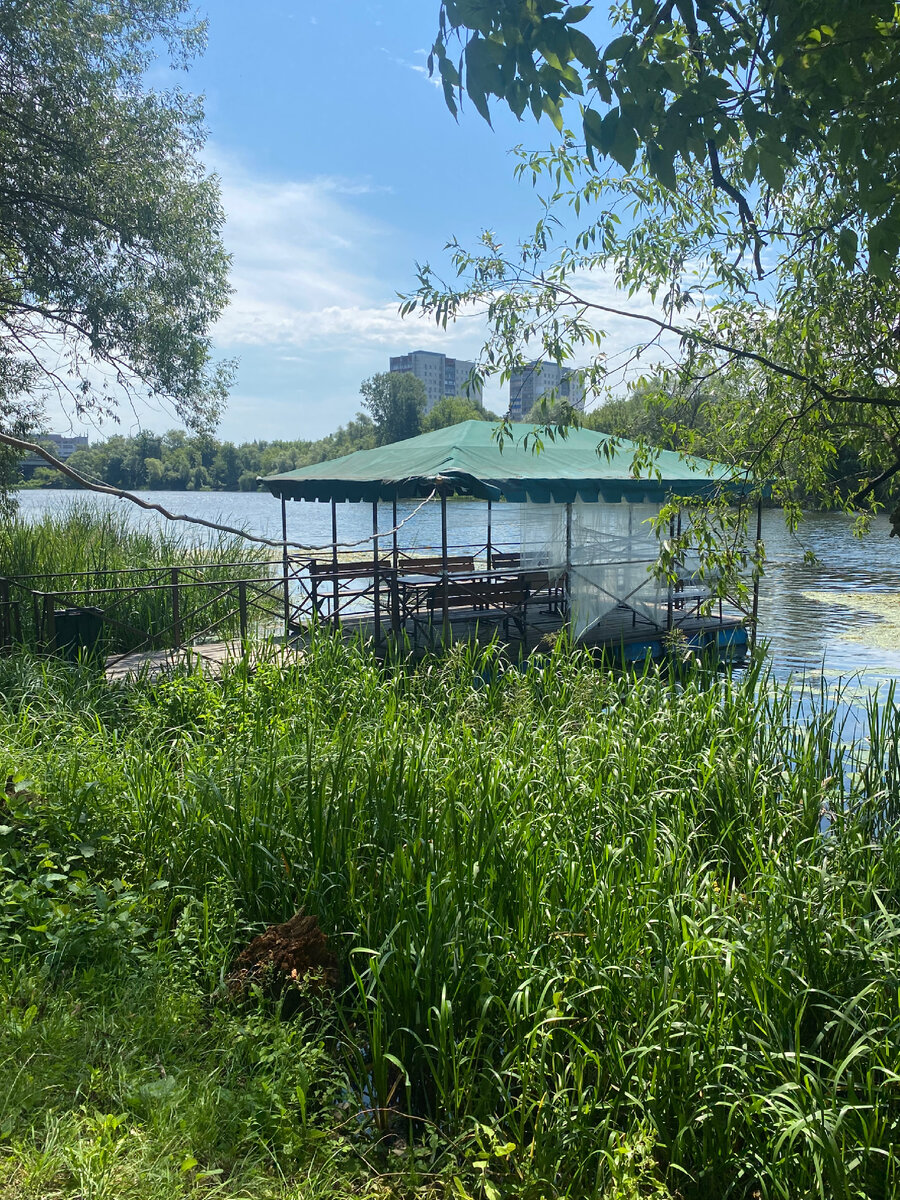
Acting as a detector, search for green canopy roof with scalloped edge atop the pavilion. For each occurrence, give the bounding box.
[262,421,730,504]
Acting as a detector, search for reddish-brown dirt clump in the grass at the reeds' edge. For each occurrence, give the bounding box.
[226,913,338,1000]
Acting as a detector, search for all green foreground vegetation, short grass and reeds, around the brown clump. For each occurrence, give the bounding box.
[0,637,900,1200]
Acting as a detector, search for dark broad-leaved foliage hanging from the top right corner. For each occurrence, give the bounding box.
[431,0,900,277]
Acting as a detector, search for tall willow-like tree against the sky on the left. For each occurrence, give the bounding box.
[0,0,236,446]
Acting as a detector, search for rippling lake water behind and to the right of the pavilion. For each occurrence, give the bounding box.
[12,491,900,689]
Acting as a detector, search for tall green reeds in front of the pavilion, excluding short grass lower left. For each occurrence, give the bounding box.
[0,636,900,1200]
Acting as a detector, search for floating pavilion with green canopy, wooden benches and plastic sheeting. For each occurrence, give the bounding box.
[262,421,758,660]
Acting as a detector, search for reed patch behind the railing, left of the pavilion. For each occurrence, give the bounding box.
[0,500,278,653]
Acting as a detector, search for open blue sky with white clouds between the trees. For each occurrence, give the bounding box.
[56,0,662,442]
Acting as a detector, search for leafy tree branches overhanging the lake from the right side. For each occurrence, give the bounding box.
[415,0,900,535]
